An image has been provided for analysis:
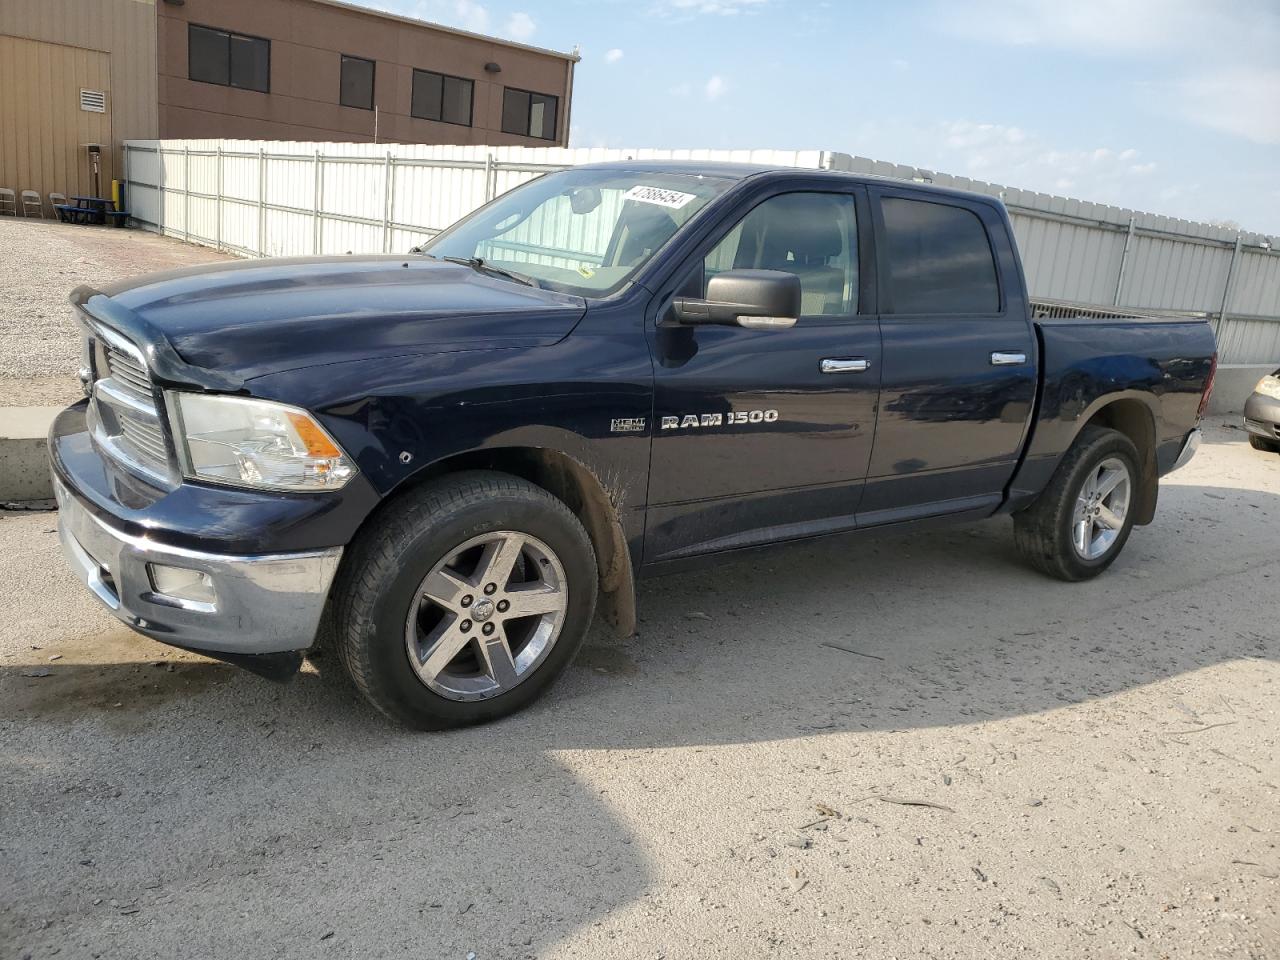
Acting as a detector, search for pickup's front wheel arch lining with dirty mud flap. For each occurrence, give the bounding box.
[365,445,636,636]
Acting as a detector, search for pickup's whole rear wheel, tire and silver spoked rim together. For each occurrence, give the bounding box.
[1014,426,1140,581]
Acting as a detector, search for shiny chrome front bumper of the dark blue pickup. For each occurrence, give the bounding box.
[54,475,342,654]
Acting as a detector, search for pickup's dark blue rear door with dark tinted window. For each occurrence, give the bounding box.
[858,186,1037,525]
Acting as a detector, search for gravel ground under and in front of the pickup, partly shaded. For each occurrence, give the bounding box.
[0,422,1280,960]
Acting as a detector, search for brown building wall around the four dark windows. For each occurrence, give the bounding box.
[157,0,572,146]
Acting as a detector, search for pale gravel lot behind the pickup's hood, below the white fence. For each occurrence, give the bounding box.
[0,216,230,407]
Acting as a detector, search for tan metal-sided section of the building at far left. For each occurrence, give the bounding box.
[0,0,159,207]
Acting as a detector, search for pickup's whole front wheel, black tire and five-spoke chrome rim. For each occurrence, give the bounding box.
[334,472,596,730]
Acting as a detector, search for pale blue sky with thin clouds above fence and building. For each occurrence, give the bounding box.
[355,0,1280,234]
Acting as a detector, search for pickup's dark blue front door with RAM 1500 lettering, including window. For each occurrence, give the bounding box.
[645,187,881,562]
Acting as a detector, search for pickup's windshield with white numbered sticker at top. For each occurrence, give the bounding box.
[421,169,733,297]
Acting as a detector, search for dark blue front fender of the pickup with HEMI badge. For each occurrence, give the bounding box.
[250,332,653,560]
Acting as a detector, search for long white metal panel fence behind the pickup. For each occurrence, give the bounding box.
[124,140,1280,364]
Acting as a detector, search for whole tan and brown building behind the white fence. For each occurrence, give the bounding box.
[0,0,577,209]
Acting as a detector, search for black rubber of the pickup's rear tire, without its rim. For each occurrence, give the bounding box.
[1014,426,1142,581]
